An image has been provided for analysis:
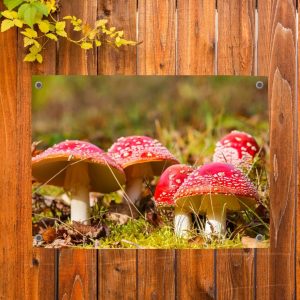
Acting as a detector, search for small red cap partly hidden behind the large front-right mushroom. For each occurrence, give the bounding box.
[154,165,194,205]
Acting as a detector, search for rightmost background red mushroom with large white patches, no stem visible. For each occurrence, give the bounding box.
[213,130,259,169]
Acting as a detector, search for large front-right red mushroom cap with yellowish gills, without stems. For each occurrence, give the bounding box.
[174,162,259,213]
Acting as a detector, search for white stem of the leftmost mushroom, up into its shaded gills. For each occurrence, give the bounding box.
[64,163,90,224]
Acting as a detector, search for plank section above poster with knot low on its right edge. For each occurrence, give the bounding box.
[177,0,216,75]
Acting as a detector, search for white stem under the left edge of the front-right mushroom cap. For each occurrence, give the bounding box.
[174,207,192,237]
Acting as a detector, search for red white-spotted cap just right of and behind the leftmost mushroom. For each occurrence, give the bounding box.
[107,136,179,177]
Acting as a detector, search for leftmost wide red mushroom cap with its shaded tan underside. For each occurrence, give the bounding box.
[32,140,125,193]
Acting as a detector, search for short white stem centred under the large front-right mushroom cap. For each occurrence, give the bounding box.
[205,207,226,235]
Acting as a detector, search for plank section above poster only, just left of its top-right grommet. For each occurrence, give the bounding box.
[217,0,255,75]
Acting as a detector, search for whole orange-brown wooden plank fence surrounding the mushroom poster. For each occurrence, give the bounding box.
[0,0,300,300]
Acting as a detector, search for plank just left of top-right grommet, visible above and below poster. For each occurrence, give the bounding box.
[216,0,255,299]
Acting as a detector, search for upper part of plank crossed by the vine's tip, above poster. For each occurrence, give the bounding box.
[98,0,137,75]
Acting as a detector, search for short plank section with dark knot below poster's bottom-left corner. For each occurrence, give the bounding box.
[30,248,56,300]
